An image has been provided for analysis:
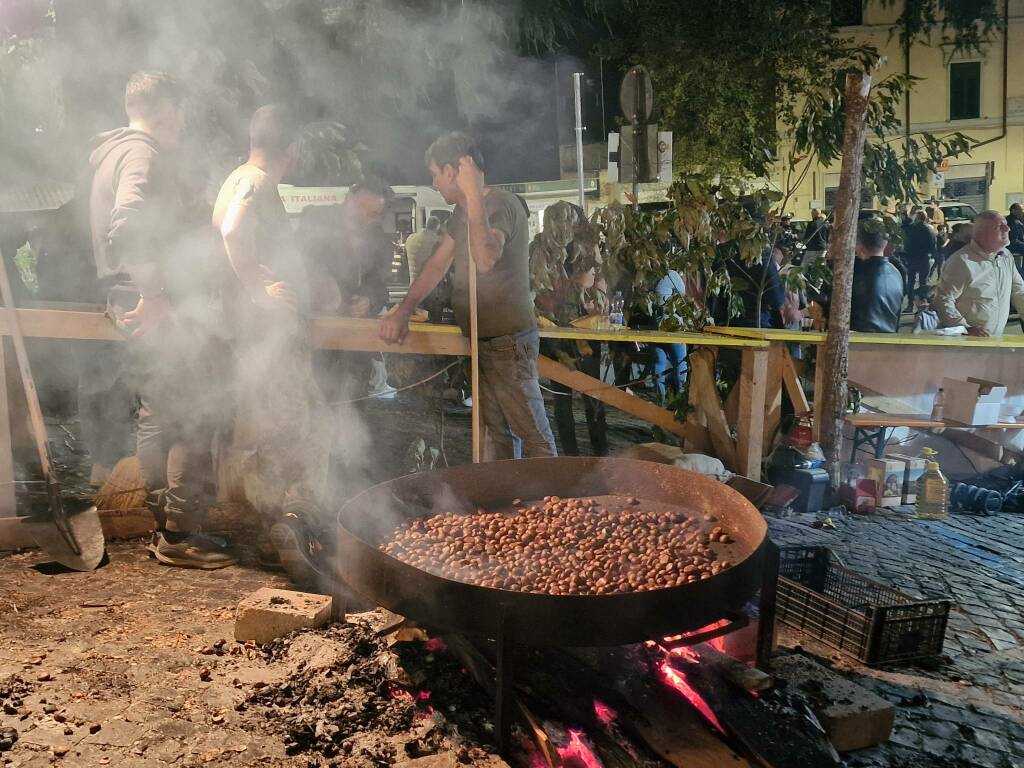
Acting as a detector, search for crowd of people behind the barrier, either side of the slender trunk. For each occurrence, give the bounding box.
[761,203,1024,336]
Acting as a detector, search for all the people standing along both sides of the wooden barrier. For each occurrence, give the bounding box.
[74,72,1024,575]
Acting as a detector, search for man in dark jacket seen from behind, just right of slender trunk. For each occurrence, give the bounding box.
[850,219,903,334]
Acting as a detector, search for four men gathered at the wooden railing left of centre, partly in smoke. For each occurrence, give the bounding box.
[90,72,569,581]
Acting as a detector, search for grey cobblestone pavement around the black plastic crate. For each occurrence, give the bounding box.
[770,512,1024,768]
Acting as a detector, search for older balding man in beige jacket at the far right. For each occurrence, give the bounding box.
[935,211,1024,336]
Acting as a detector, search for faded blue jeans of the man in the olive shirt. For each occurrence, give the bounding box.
[473,328,557,461]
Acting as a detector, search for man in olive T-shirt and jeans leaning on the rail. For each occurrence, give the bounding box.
[381,133,555,461]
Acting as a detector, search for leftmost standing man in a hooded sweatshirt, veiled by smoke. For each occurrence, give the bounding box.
[89,72,236,568]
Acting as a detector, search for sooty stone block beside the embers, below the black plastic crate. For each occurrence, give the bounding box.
[771,655,896,752]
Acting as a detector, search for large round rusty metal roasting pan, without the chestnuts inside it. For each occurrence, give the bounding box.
[338,457,767,647]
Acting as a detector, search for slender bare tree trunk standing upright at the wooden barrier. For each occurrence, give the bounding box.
[815,73,871,486]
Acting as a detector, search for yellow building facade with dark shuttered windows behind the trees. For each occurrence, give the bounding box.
[772,0,1024,218]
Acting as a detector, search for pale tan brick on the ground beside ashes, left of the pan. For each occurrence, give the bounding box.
[234,587,331,643]
